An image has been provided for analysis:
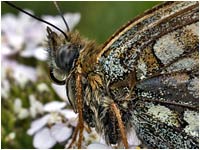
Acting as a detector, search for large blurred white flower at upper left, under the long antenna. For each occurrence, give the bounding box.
[1,11,46,52]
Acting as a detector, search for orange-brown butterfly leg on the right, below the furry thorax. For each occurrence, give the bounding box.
[111,102,128,149]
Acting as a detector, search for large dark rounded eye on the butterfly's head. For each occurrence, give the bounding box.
[55,45,79,73]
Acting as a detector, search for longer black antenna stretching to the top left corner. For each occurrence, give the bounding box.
[4,1,69,40]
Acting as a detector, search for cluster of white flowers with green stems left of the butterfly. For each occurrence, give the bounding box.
[1,11,85,148]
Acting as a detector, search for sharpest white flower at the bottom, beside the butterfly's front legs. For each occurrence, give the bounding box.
[27,101,76,148]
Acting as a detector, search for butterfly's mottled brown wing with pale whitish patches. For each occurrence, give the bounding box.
[96,1,199,148]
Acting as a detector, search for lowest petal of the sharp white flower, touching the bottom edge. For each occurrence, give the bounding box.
[33,128,56,148]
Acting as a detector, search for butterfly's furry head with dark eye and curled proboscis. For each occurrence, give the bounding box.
[47,27,83,84]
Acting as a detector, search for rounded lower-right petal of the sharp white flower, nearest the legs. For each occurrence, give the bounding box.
[51,123,72,142]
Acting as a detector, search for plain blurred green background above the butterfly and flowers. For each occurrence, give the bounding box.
[2,1,161,43]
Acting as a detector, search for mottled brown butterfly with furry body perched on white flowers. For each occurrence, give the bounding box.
[4,1,199,149]
